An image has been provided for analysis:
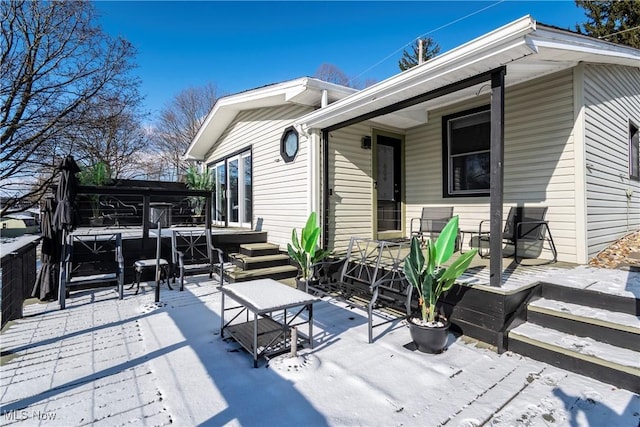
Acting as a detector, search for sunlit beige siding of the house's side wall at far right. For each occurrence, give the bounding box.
[584,64,640,256]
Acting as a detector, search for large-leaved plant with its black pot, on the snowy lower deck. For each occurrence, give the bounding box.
[404,216,477,353]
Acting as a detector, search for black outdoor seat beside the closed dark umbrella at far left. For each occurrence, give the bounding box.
[60,233,124,308]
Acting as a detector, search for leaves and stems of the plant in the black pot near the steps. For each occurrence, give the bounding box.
[404,216,478,325]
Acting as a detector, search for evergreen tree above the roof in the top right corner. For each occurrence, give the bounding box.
[576,0,640,49]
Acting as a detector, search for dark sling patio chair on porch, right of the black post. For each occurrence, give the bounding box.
[470,206,558,264]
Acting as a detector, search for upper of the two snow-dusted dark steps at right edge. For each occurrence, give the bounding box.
[527,298,640,351]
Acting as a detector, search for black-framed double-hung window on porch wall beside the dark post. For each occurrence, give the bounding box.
[442,107,491,197]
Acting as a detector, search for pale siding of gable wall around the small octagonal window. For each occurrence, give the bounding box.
[206,106,311,249]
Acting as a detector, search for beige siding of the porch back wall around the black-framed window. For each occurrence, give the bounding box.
[405,71,576,261]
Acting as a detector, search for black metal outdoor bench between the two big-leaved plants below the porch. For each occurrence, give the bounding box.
[309,237,412,343]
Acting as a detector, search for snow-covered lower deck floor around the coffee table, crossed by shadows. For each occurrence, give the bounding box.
[0,267,640,426]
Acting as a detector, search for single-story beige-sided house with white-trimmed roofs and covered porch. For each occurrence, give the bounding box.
[186,16,640,278]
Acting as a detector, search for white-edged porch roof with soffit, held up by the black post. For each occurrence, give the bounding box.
[296,16,640,130]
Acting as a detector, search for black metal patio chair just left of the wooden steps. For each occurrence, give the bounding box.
[171,228,224,291]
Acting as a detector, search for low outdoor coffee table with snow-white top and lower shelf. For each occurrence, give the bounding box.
[220,279,320,368]
